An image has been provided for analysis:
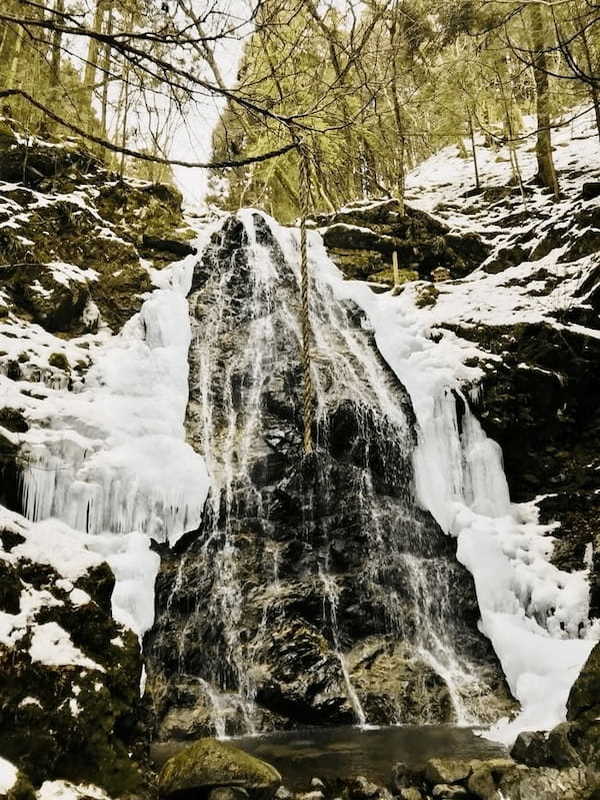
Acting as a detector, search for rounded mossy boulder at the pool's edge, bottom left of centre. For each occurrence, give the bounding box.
[159,739,281,798]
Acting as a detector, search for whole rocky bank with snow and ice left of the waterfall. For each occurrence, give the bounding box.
[0,126,209,796]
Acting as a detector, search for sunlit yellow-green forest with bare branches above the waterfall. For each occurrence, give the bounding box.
[0,0,600,214]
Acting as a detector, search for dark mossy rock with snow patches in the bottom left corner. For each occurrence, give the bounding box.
[0,530,144,795]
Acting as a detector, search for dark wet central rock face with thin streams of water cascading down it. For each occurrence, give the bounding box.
[145,216,509,739]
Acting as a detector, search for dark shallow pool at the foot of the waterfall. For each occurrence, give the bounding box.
[150,725,507,790]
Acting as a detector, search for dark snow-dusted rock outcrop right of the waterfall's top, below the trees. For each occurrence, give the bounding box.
[315,200,489,279]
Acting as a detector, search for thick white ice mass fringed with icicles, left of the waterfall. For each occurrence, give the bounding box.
[20,260,209,544]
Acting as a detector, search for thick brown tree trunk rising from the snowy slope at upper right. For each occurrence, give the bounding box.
[530,3,560,200]
